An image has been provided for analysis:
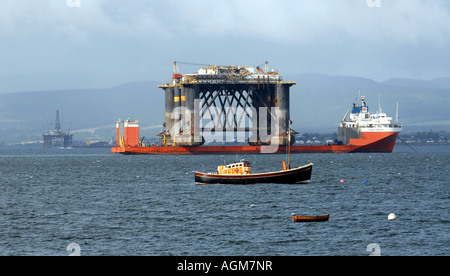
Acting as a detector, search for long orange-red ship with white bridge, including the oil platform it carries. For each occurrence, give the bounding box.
[112,62,401,154]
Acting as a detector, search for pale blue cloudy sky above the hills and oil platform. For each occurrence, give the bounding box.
[0,0,450,93]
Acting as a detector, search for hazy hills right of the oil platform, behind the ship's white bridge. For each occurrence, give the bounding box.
[284,74,450,132]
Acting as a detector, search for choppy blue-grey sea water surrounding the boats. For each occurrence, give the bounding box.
[0,147,450,256]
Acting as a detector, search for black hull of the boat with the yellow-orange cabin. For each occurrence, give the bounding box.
[195,163,313,184]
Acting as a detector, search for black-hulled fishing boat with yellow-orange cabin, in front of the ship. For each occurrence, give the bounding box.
[195,160,314,184]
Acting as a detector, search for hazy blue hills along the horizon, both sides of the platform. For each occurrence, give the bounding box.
[0,73,450,143]
